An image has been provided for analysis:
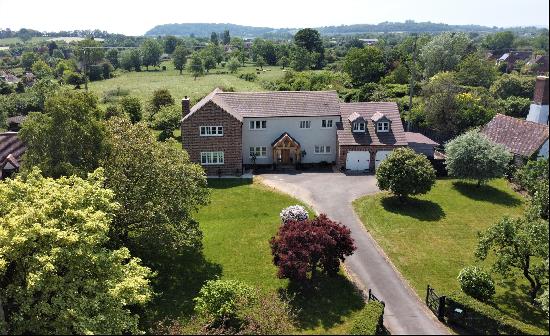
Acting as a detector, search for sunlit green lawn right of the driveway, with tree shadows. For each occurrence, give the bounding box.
[354,179,548,329]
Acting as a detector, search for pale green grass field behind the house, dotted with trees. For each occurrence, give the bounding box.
[89,61,284,104]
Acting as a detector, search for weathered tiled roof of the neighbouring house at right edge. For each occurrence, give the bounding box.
[482,114,548,156]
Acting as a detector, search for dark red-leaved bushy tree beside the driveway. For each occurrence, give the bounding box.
[269,214,356,281]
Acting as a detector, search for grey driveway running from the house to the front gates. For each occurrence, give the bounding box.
[260,172,449,335]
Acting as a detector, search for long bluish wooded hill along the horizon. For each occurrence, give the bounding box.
[145,20,537,38]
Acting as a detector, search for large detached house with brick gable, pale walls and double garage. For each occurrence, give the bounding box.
[181,89,414,176]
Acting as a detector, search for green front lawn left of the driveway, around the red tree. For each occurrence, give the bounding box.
[145,179,364,334]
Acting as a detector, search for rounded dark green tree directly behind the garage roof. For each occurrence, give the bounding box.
[344,46,385,86]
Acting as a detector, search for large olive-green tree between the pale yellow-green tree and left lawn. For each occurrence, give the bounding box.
[101,118,209,257]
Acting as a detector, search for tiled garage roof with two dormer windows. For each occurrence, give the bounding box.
[337,102,407,146]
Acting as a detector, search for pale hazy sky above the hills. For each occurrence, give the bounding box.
[0,0,549,35]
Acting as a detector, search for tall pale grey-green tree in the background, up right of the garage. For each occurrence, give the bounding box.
[420,33,471,77]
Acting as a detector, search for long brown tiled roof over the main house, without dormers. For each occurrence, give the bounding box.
[183,89,340,121]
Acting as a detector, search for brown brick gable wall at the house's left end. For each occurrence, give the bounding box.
[181,102,242,176]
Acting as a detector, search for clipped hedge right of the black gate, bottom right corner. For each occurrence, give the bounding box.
[445,293,548,335]
